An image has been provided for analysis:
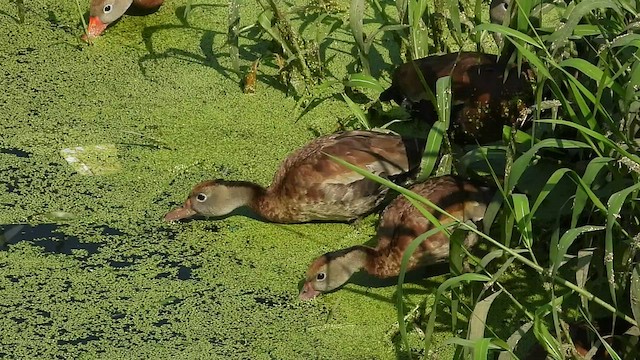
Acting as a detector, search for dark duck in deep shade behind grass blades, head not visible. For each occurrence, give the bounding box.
[380,52,534,146]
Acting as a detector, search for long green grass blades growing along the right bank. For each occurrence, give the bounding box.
[236,0,640,359]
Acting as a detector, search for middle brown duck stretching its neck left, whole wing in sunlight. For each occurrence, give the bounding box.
[164,130,426,223]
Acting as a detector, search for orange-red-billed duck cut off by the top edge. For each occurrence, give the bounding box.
[83,0,164,40]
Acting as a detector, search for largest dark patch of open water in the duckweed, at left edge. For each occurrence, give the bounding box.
[0,224,102,255]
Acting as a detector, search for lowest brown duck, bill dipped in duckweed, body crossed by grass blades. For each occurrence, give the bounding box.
[299,175,495,300]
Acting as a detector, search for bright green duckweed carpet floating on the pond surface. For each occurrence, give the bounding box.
[0,0,516,359]
